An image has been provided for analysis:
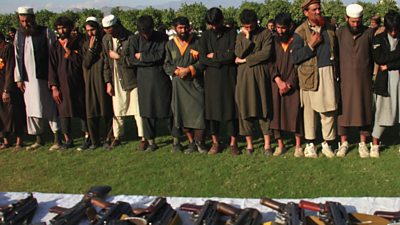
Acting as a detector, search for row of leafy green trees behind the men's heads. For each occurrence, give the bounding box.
[0,0,400,33]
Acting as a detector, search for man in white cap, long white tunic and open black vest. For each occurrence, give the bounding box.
[14,7,61,150]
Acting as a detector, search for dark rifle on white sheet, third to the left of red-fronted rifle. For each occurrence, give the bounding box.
[179,200,223,225]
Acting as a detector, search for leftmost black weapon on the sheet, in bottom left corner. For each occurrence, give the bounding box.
[0,193,38,225]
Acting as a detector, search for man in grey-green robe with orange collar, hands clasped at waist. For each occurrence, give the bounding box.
[164,17,207,153]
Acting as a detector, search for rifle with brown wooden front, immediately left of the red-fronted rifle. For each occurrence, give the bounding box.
[260,198,305,225]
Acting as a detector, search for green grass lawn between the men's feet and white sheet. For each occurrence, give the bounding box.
[0,118,400,198]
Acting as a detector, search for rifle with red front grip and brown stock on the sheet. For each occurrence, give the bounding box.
[299,200,390,225]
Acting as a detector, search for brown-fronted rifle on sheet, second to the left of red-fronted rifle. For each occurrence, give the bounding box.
[217,202,262,225]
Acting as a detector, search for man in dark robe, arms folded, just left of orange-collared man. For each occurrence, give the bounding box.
[127,15,171,151]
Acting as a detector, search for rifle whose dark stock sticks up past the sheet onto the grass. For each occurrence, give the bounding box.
[31,186,111,225]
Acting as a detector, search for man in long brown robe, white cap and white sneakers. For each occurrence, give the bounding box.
[336,4,374,158]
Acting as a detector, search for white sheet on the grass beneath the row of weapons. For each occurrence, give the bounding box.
[0,192,400,225]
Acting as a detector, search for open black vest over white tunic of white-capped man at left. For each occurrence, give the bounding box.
[15,26,49,81]
